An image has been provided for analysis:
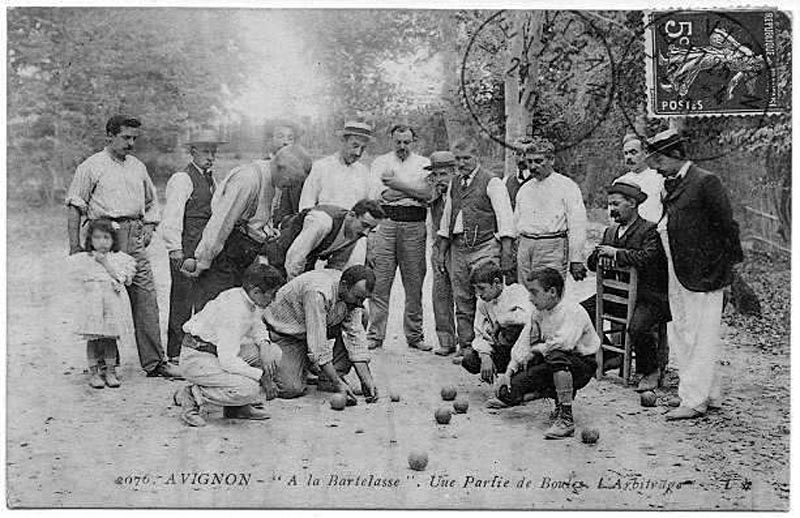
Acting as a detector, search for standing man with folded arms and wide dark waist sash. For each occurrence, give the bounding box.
[367,124,433,351]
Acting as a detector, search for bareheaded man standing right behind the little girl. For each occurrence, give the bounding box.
[66,115,178,377]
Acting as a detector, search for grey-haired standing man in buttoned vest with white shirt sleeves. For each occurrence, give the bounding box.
[436,141,514,362]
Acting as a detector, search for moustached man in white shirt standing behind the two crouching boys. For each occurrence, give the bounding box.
[514,138,586,283]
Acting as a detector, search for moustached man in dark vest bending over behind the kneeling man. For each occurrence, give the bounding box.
[278,200,386,280]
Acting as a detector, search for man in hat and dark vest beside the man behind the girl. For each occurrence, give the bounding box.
[161,131,225,363]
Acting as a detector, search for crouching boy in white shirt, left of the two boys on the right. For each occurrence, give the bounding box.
[461,261,533,383]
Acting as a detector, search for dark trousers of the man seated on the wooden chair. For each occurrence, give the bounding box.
[581,295,669,374]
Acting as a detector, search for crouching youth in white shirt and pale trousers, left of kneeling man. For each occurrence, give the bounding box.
[175,263,285,426]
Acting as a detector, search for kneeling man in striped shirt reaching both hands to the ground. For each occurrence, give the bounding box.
[264,265,378,405]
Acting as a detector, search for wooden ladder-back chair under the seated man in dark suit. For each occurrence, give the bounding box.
[595,266,669,386]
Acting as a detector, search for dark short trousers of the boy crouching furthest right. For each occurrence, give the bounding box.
[501,351,597,405]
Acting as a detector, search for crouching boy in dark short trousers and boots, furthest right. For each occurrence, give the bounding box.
[495,268,600,439]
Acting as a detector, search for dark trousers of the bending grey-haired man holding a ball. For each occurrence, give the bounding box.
[195,229,263,311]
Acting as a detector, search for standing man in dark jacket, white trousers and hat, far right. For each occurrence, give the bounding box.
[645,130,744,420]
